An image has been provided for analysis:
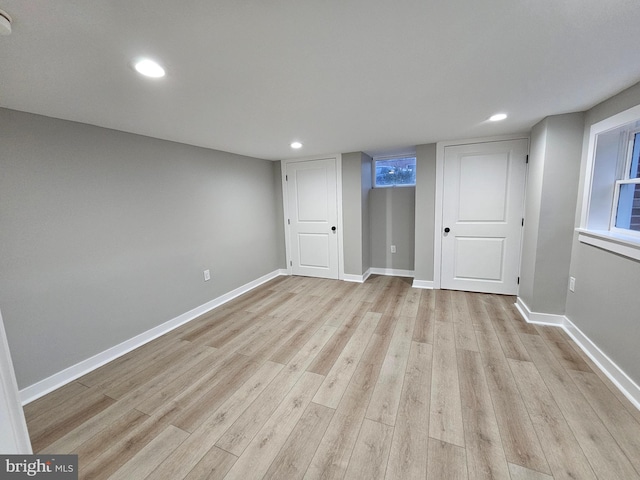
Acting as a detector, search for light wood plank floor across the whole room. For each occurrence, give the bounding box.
[25,276,640,480]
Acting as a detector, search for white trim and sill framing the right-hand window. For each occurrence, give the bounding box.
[576,101,640,260]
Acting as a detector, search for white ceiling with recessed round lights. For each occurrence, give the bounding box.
[0,0,640,159]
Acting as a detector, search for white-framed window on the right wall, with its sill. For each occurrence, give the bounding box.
[578,105,640,260]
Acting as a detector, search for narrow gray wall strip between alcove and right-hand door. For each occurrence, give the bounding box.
[414,143,436,282]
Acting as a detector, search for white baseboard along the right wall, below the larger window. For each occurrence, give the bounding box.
[516,297,640,410]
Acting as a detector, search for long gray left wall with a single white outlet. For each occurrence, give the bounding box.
[0,109,283,388]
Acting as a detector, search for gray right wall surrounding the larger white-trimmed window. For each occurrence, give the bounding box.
[566,79,640,384]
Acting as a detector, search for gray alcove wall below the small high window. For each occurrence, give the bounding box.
[369,187,416,270]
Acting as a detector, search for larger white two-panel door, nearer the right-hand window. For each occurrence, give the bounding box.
[440,140,528,295]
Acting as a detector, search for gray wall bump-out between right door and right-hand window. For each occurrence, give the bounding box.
[519,113,584,315]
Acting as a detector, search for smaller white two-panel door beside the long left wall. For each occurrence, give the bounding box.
[285,158,338,279]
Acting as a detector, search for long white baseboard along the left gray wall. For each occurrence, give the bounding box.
[20,269,287,405]
